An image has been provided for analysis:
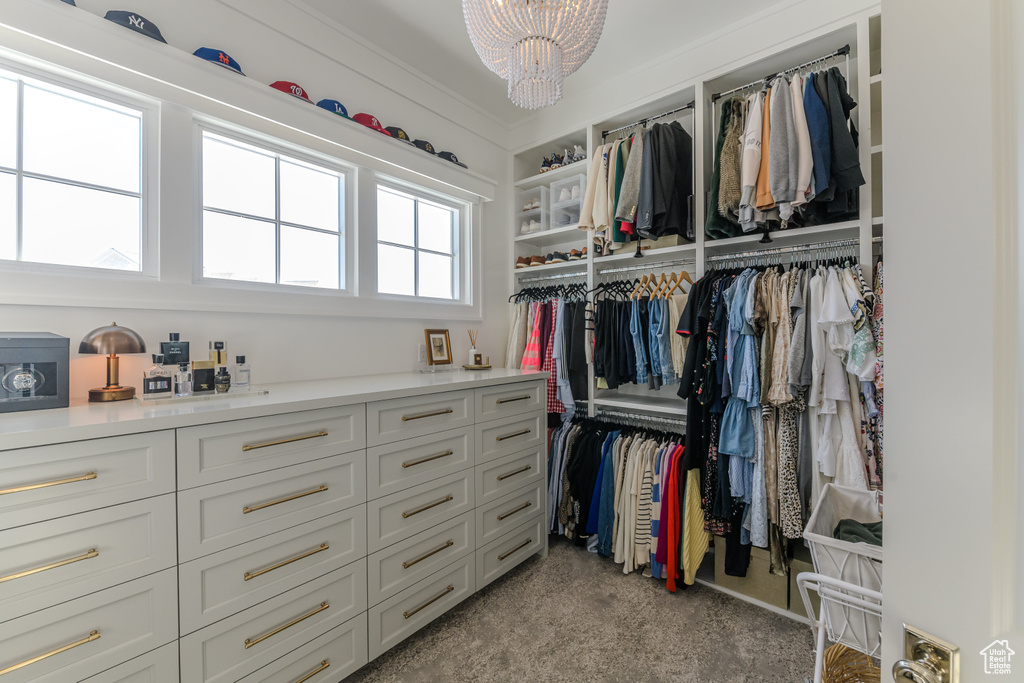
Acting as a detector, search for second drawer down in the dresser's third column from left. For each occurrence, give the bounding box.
[367,427,473,501]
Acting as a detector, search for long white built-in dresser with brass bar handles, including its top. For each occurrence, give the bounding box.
[0,371,547,683]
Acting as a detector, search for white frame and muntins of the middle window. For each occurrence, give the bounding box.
[193,123,358,297]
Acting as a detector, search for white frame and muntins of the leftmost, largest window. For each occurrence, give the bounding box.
[0,59,160,280]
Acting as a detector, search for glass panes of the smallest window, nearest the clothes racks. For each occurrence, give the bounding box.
[377,185,459,299]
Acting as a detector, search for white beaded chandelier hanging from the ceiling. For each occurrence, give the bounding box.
[462,0,608,110]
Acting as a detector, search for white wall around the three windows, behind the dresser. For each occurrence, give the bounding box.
[0,0,511,399]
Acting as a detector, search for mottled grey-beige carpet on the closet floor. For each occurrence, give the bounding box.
[347,541,814,683]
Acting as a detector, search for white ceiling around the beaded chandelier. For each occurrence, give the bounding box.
[296,0,792,124]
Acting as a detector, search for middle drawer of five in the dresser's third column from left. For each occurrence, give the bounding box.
[367,470,474,553]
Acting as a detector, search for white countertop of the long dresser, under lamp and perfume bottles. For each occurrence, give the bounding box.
[0,369,547,451]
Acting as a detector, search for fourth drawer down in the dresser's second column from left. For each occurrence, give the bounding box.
[180,559,367,683]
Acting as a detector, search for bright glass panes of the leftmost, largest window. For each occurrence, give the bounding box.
[0,71,144,272]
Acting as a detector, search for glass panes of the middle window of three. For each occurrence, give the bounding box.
[202,131,345,290]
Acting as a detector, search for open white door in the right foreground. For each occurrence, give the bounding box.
[883,0,1024,681]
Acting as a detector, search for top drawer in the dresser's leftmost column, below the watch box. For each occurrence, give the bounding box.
[0,431,174,528]
